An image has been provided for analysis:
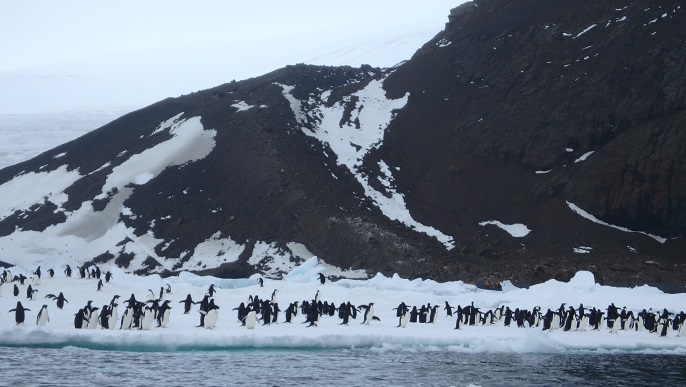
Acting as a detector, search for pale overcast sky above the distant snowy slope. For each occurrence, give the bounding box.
[0,0,463,71]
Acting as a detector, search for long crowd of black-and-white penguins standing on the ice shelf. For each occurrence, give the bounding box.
[0,265,686,337]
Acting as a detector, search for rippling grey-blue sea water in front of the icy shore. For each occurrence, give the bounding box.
[0,347,686,387]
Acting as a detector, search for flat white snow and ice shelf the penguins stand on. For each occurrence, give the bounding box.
[0,258,686,354]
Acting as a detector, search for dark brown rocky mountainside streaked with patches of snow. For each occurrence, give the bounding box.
[0,0,686,284]
